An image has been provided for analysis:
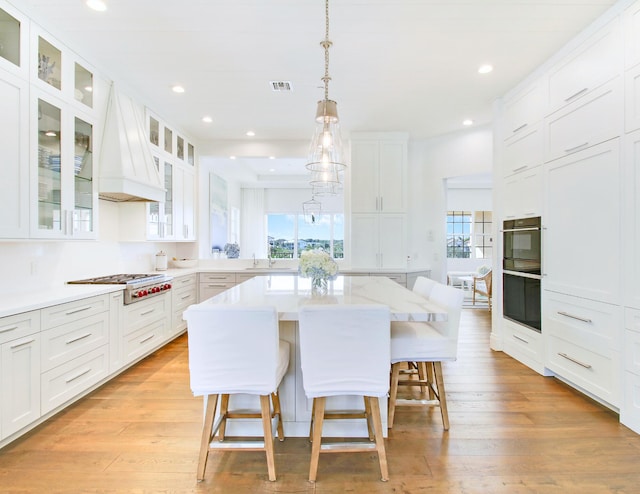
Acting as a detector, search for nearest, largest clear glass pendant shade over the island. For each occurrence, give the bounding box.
[307,99,346,172]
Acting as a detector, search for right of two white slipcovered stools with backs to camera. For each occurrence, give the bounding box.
[299,305,391,482]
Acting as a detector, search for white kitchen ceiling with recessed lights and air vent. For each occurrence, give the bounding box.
[18,0,615,174]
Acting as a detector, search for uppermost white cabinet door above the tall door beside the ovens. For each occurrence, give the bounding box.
[547,17,623,114]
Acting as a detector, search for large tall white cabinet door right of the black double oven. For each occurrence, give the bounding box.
[542,139,622,303]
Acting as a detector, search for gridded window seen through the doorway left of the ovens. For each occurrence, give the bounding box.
[447,211,493,259]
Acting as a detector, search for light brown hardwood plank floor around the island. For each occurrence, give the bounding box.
[0,309,640,494]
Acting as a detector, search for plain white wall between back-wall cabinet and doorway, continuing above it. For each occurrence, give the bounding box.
[409,125,495,282]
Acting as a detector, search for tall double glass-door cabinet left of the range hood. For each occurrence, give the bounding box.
[31,97,96,238]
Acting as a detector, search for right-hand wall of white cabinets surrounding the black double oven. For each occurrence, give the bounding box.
[495,1,640,432]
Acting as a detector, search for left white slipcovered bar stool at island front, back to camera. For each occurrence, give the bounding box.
[184,304,289,481]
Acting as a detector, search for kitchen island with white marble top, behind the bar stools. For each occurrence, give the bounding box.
[182,275,446,437]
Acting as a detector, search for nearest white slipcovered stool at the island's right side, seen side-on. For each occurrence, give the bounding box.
[388,283,464,430]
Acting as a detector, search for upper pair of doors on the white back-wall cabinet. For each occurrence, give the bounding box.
[351,138,407,213]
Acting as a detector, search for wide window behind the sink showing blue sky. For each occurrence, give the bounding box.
[267,213,344,259]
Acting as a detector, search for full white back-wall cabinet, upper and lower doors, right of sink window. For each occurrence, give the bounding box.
[350,133,408,268]
